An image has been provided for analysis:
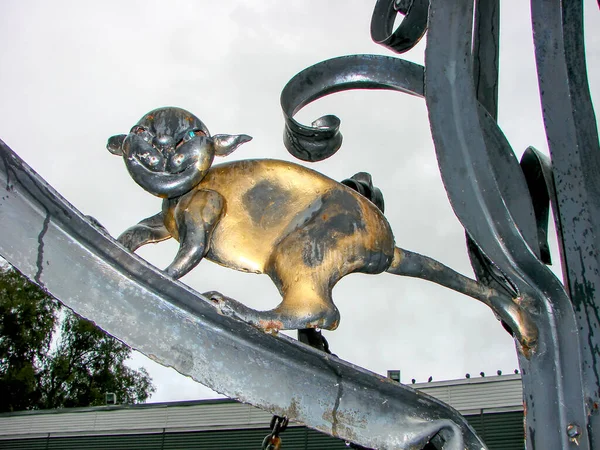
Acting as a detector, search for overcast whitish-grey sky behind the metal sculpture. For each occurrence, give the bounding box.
[0,0,600,401]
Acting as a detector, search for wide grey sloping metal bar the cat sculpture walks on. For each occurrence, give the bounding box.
[0,141,485,450]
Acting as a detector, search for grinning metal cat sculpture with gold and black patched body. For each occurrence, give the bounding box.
[107,107,536,345]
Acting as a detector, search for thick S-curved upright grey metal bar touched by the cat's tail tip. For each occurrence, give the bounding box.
[425,0,588,449]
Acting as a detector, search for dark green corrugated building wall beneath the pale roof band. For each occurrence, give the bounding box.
[0,412,525,450]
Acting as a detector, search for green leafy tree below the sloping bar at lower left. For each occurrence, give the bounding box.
[0,267,155,412]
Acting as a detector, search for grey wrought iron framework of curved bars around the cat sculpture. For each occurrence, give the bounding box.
[0,0,600,449]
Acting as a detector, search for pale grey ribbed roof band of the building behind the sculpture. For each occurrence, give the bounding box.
[0,375,523,440]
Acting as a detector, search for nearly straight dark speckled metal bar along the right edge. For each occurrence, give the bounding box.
[531,0,600,446]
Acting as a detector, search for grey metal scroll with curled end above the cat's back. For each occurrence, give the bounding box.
[281,55,423,162]
